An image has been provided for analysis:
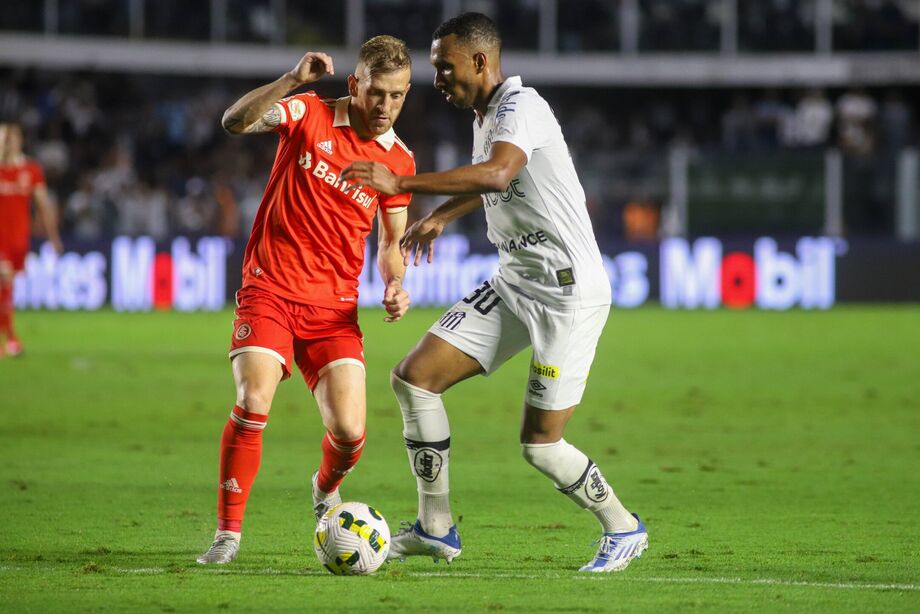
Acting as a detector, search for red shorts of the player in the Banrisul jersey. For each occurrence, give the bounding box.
[230,288,364,390]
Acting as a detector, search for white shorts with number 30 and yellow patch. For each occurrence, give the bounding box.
[428,278,610,409]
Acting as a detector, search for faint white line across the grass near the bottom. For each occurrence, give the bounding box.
[0,565,920,591]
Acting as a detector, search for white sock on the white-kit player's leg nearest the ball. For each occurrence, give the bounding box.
[390,373,454,537]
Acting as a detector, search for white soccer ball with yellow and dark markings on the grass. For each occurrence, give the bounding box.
[313,501,390,576]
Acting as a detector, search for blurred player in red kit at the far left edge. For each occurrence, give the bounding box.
[0,122,63,357]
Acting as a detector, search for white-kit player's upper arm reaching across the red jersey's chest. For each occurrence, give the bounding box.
[342,141,527,194]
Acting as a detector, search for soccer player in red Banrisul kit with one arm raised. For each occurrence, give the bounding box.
[198,36,415,564]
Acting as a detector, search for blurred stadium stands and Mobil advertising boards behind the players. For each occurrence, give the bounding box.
[0,0,920,310]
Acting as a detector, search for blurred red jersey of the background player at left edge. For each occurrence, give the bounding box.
[0,156,45,251]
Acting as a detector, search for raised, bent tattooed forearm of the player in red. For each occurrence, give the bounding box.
[221,51,335,134]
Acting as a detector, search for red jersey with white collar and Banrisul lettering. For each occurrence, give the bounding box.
[243,92,415,307]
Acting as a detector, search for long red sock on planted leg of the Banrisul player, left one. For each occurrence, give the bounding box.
[217,406,268,533]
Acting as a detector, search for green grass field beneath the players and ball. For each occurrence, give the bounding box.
[0,307,920,612]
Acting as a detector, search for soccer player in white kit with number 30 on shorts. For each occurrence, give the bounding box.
[342,13,648,572]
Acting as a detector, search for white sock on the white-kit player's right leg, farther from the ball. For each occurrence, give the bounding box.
[521,439,639,533]
